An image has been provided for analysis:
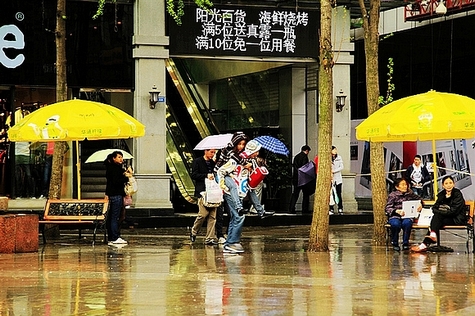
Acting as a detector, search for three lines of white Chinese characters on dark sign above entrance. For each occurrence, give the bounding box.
[195,8,309,55]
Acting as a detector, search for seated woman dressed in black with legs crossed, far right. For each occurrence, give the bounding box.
[411,176,467,252]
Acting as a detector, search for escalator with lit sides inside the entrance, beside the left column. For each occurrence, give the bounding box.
[166,59,218,203]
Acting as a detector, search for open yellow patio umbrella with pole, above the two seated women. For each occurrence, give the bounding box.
[356,90,475,194]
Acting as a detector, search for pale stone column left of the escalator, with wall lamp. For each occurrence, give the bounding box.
[133,0,172,209]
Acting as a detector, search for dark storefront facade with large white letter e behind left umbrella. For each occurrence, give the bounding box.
[0,0,134,198]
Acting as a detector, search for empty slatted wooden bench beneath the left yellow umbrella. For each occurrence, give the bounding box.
[39,199,109,245]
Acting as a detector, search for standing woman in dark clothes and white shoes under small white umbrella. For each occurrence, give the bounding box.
[104,151,132,246]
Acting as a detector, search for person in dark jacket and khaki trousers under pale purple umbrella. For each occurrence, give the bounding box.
[190,149,218,245]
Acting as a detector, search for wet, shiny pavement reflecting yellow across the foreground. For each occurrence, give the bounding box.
[0,225,475,315]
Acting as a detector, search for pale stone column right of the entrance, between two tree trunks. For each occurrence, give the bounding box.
[332,7,358,213]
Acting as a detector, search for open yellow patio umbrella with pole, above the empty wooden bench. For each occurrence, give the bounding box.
[8,99,145,199]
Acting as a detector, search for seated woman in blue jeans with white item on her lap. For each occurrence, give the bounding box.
[386,178,422,251]
